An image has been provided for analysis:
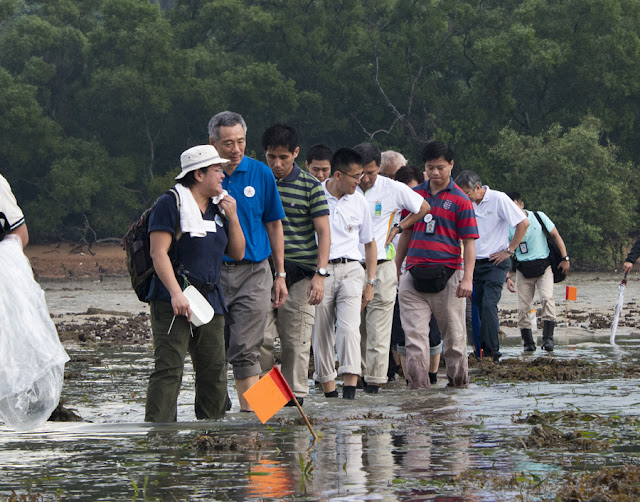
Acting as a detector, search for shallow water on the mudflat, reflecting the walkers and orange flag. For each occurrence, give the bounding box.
[0,274,640,501]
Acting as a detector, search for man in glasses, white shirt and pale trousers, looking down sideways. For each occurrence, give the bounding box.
[312,148,377,399]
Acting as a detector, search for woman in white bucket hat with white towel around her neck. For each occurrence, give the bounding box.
[145,145,245,422]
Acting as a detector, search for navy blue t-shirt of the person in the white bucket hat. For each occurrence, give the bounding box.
[147,193,227,314]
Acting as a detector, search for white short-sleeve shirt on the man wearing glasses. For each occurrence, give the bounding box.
[322,178,373,261]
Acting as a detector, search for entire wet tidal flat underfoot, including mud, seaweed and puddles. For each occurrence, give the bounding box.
[0,253,640,501]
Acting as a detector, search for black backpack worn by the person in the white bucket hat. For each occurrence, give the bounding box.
[120,188,182,302]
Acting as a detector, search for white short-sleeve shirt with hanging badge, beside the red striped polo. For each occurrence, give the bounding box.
[356,176,424,260]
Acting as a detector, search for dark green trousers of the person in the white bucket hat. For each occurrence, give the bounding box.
[145,301,227,422]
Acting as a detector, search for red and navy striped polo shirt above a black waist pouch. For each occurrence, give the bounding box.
[407,179,478,270]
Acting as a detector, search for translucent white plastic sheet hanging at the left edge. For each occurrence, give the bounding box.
[0,236,69,430]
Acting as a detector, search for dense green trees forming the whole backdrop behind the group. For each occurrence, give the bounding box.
[0,0,640,265]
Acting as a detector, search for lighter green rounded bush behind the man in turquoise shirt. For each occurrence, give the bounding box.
[492,117,637,265]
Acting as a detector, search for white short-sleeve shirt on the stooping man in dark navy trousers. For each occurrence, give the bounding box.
[473,185,526,260]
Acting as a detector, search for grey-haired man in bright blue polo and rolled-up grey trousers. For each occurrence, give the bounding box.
[209,111,287,411]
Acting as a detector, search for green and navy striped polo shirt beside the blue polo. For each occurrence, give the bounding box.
[276,164,329,270]
